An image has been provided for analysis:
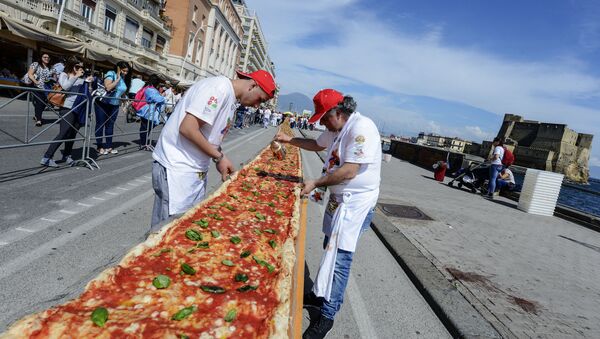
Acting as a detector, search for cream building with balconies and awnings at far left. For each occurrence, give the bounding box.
[0,0,171,75]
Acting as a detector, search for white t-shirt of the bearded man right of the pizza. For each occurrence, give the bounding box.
[317,112,381,194]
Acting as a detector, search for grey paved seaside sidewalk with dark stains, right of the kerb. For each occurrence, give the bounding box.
[379,158,600,338]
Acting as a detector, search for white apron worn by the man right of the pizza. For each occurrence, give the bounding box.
[313,113,379,301]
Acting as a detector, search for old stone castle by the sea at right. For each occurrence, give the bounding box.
[488,114,594,183]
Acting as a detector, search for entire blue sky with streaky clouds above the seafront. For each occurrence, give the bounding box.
[248,0,600,170]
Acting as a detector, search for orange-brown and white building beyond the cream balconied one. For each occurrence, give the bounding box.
[165,0,243,85]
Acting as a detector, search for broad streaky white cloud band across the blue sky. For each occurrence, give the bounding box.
[249,0,600,154]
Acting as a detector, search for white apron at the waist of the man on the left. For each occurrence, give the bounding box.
[167,169,206,215]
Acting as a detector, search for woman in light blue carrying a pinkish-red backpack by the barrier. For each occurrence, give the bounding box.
[133,74,165,151]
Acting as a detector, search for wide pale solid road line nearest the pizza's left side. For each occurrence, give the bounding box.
[0,190,154,280]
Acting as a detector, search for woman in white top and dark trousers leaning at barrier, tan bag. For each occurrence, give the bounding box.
[40,57,94,167]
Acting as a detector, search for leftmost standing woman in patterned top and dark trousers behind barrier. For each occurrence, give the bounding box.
[27,53,52,126]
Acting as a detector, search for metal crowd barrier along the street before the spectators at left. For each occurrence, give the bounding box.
[0,85,156,170]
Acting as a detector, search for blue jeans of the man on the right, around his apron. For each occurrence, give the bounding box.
[321,209,374,320]
